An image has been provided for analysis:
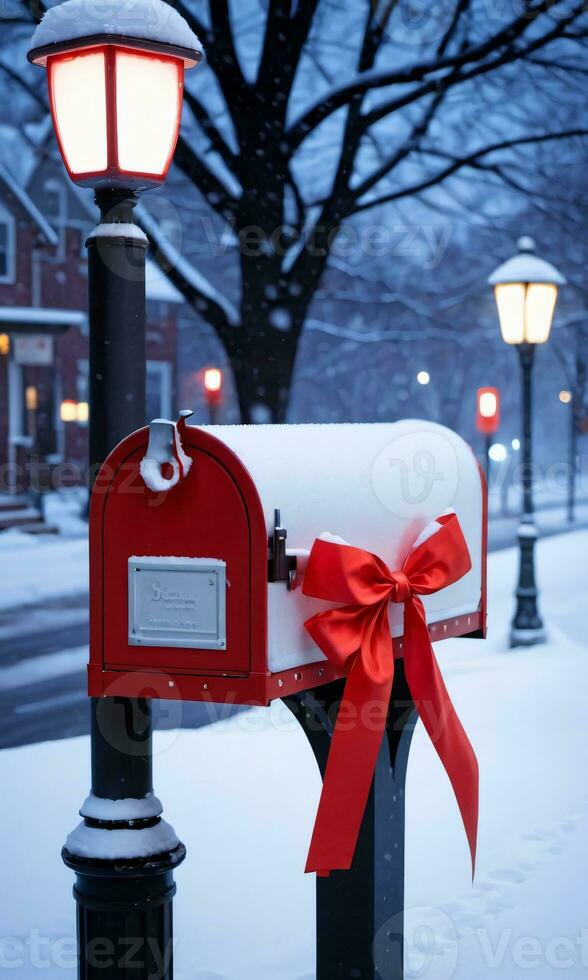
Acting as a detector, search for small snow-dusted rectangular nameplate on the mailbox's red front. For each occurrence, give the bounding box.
[129,556,227,650]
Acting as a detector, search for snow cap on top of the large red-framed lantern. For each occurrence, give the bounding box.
[31,0,202,54]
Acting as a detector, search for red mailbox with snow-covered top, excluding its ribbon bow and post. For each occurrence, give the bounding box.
[89,413,486,705]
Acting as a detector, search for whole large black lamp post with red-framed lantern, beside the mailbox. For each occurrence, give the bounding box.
[28,0,202,980]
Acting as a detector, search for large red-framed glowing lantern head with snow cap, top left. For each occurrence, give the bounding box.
[28,0,202,189]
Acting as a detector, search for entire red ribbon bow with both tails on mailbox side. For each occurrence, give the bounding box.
[302,513,478,875]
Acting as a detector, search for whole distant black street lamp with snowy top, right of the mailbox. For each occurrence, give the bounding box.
[488,236,565,647]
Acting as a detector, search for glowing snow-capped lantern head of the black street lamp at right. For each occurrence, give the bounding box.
[488,236,566,344]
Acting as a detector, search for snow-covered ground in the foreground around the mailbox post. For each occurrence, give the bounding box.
[0,531,588,980]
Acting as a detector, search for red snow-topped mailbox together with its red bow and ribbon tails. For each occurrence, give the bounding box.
[88,413,486,873]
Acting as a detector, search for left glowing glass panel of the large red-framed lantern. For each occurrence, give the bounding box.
[49,51,108,176]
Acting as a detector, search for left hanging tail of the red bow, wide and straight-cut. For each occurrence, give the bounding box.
[305,649,394,877]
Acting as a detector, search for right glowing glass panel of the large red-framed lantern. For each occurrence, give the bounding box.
[116,51,183,177]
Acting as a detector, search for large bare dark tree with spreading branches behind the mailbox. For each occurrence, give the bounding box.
[4,0,586,421]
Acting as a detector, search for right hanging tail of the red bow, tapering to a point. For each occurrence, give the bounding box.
[404,596,479,878]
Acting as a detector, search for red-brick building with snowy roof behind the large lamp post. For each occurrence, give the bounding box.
[0,153,183,502]
